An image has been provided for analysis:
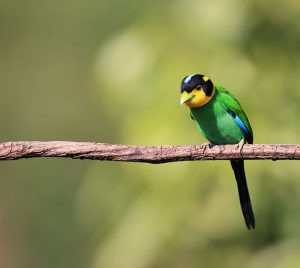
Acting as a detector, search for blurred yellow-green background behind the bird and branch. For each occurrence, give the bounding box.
[0,0,300,268]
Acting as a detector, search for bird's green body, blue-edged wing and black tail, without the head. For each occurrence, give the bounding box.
[184,84,255,229]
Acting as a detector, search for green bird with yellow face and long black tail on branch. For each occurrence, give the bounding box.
[180,74,255,230]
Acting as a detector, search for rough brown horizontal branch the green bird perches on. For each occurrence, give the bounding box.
[0,141,300,164]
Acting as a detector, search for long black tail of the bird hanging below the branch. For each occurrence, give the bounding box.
[230,160,255,230]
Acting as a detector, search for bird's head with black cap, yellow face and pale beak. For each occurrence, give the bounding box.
[180,74,215,108]
